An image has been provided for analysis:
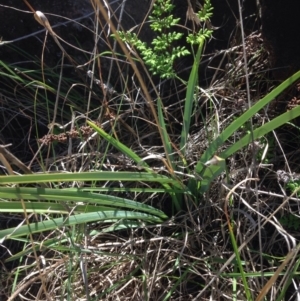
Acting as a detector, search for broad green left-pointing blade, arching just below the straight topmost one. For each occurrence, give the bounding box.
[0,187,167,219]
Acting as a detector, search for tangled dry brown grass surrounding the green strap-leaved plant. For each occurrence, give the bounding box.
[1,1,299,301]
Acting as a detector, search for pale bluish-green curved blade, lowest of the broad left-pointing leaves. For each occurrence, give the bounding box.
[0,210,163,240]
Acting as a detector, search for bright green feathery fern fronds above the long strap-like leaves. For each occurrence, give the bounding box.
[118,0,213,78]
